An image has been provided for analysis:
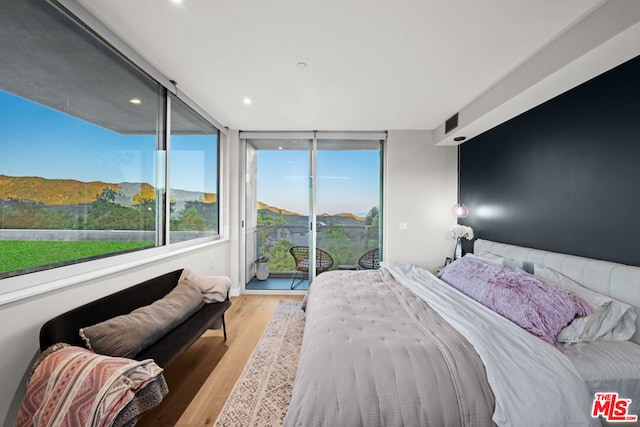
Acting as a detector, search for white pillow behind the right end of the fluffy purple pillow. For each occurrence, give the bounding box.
[533,264,636,343]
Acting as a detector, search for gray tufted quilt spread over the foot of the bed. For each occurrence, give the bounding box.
[284,269,494,427]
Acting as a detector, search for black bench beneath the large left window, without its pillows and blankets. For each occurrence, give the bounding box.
[40,270,231,367]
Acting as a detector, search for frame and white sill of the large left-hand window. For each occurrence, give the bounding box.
[0,0,228,305]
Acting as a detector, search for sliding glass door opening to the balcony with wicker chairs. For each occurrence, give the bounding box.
[241,132,384,290]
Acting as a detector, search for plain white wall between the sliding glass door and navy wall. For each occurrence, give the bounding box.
[383,130,457,272]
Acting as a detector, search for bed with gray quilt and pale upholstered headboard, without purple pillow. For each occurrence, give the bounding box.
[284,240,640,426]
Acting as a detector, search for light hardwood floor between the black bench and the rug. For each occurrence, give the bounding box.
[136,295,302,427]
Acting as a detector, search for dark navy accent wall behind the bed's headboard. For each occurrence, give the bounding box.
[460,57,640,266]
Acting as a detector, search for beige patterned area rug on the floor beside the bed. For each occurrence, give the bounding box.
[215,301,304,427]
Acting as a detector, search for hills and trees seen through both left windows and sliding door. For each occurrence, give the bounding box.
[0,175,378,271]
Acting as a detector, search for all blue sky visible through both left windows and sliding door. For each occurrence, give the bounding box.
[0,91,380,216]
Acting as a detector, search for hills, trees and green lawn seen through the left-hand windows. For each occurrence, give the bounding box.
[0,175,218,277]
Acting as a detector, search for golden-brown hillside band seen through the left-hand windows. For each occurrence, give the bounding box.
[0,175,217,206]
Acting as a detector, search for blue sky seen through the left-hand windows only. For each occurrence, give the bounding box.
[0,91,217,193]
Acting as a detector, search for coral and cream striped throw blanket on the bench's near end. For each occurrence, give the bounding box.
[15,344,167,427]
